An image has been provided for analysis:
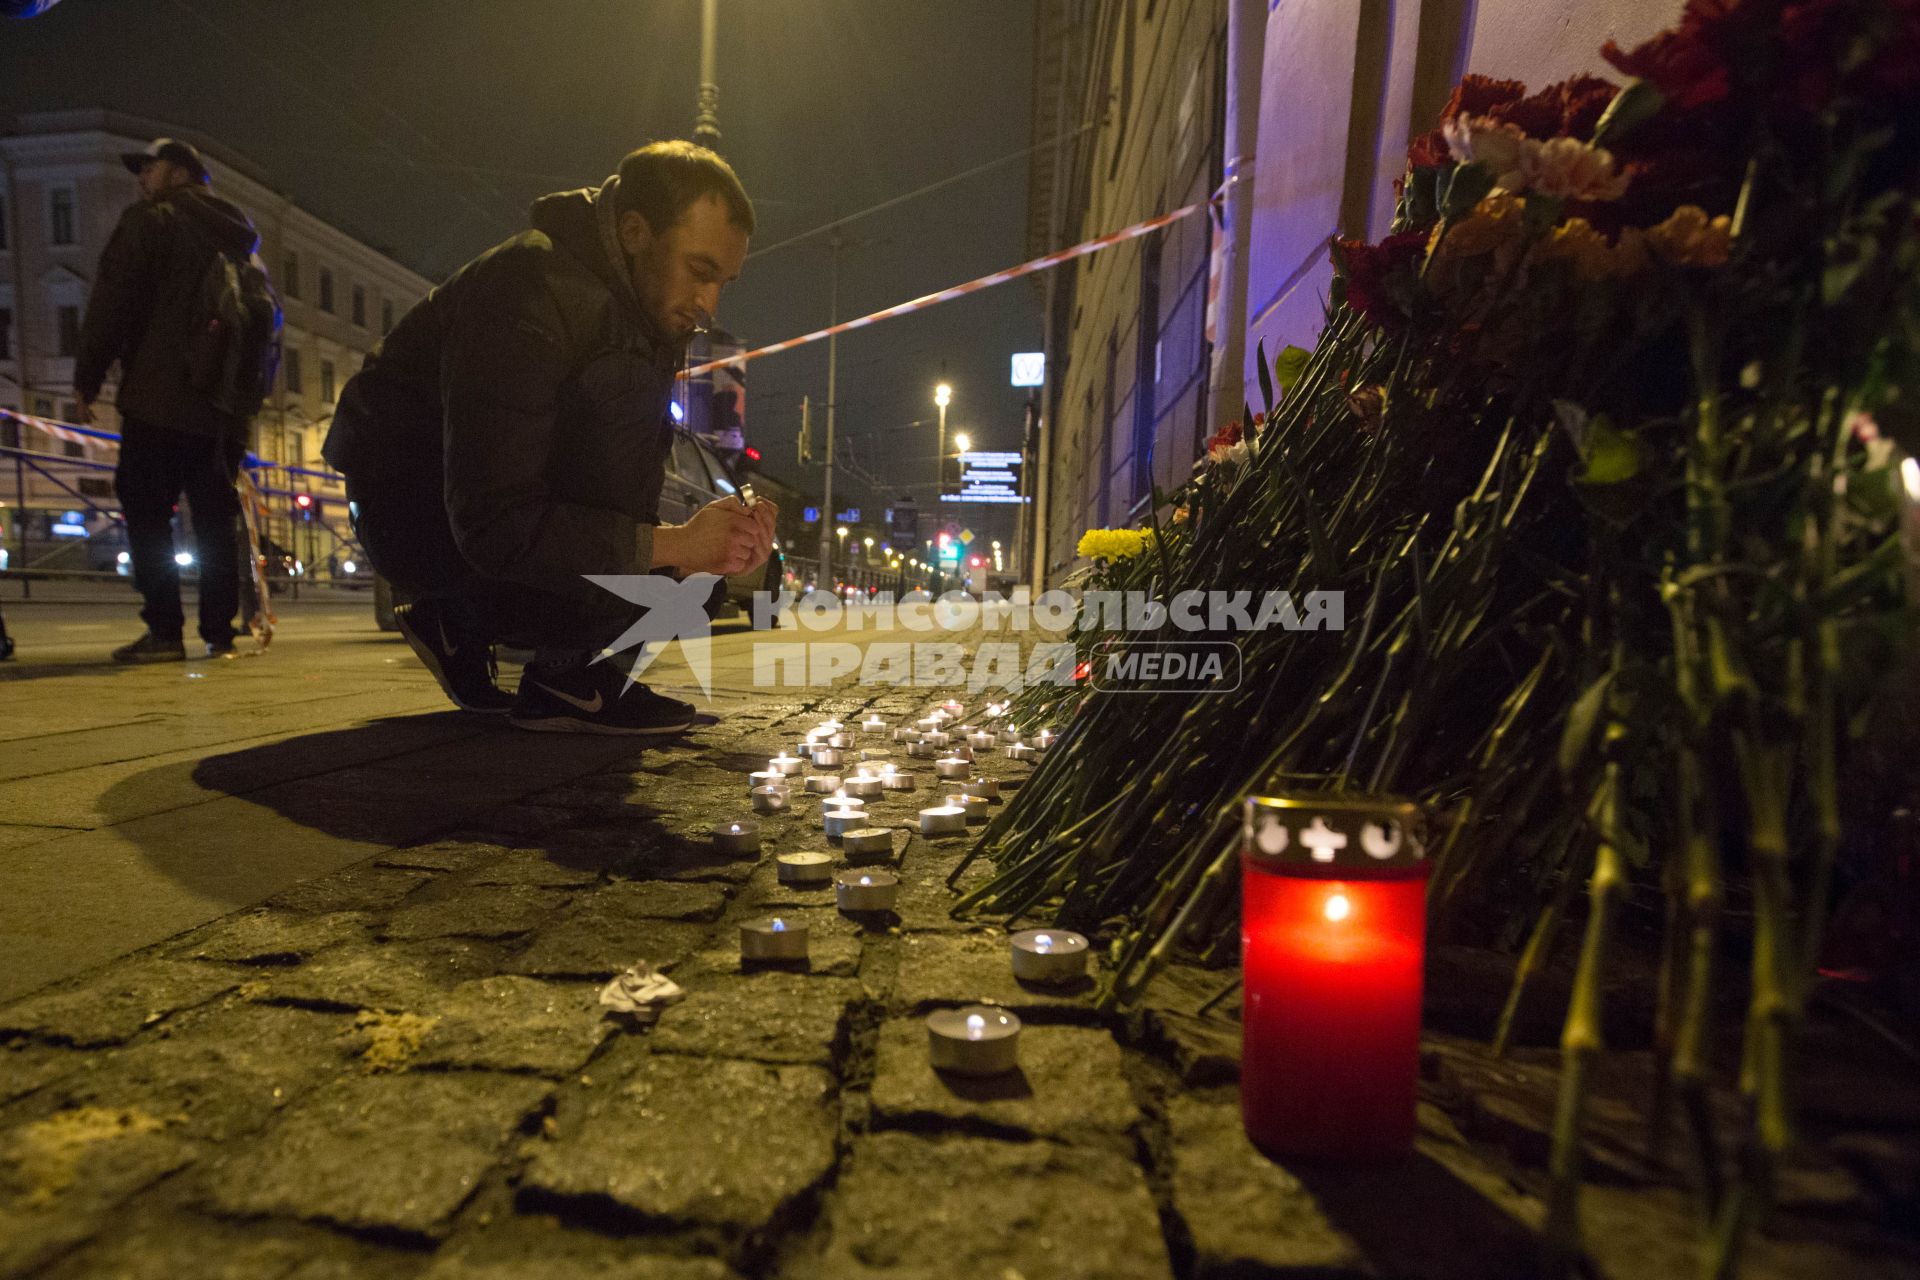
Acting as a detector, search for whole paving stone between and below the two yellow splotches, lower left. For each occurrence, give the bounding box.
[202,1073,549,1238]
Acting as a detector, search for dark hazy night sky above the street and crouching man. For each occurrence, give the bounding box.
[0,0,1041,520]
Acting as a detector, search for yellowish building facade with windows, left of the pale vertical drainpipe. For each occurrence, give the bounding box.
[1033,0,1227,570]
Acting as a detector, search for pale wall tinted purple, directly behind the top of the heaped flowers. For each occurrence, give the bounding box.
[1248,0,1682,364]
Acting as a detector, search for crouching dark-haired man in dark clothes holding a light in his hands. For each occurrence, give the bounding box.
[324,142,778,735]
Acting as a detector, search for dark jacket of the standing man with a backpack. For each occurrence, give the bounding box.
[73,186,259,441]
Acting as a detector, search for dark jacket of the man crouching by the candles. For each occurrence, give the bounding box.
[324,180,682,595]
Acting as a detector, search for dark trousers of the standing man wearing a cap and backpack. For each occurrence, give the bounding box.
[113,420,246,645]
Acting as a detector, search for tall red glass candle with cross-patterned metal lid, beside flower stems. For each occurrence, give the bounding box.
[1240,796,1427,1161]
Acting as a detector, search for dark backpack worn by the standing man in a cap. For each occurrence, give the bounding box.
[186,238,280,418]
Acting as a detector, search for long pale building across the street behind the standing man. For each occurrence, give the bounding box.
[0,111,432,560]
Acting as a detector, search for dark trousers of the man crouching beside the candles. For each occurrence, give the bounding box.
[348,476,726,660]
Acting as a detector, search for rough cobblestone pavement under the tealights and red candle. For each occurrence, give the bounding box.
[0,606,1920,1280]
